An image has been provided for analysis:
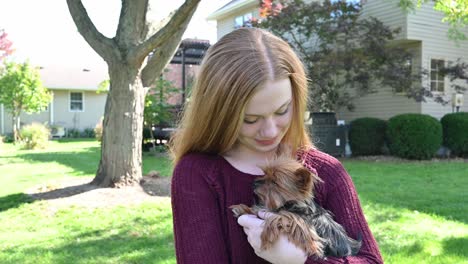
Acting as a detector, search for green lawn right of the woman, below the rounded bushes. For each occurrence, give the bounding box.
[344,161,468,263]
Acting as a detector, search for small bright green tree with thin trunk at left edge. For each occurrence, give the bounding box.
[0,62,52,141]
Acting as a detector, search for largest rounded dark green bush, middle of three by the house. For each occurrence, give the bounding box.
[386,114,442,159]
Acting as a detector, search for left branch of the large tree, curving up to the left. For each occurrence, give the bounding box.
[67,0,118,62]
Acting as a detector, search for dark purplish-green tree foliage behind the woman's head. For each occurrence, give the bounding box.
[254,0,421,111]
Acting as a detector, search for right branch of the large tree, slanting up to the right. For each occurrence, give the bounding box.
[131,0,200,64]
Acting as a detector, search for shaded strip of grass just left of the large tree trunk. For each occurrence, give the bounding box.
[17,147,101,176]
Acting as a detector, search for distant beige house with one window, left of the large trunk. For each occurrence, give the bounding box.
[0,65,108,137]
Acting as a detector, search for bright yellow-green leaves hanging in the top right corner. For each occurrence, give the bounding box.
[398,0,468,40]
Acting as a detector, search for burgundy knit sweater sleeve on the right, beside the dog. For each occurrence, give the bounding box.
[305,151,383,264]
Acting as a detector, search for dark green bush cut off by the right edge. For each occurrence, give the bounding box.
[440,113,468,156]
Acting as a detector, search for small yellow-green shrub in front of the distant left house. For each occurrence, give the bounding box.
[20,123,50,149]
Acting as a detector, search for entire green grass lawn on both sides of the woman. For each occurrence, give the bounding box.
[0,140,468,264]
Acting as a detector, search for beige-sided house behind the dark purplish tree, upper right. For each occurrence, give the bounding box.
[208,0,468,122]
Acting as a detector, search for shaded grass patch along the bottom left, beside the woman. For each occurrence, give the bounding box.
[3,222,176,264]
